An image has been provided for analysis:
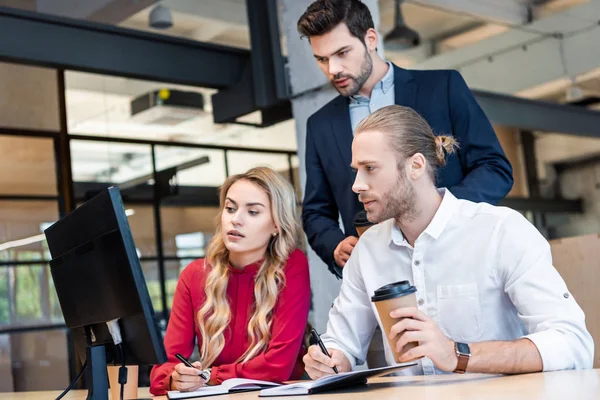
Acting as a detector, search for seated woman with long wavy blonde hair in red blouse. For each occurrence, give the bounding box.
[150,167,310,395]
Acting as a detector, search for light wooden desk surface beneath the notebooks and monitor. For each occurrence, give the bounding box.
[0,369,600,400]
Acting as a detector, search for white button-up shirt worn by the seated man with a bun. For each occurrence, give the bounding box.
[322,189,594,375]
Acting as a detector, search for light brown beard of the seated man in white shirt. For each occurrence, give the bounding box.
[365,170,418,224]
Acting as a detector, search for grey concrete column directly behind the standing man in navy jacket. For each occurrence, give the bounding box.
[280,0,383,332]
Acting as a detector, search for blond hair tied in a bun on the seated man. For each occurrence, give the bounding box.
[355,105,458,177]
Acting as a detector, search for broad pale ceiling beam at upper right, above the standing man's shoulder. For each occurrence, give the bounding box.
[412,1,600,94]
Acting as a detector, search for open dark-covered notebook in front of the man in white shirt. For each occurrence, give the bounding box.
[259,363,417,397]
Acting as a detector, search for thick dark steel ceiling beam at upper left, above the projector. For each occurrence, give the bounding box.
[0,8,250,89]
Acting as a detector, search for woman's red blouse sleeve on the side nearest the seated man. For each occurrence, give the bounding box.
[210,250,310,384]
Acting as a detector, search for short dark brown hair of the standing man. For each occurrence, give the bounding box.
[298,0,375,43]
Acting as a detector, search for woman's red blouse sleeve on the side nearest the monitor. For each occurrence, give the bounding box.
[150,264,196,396]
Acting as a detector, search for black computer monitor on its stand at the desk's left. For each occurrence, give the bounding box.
[44,187,167,399]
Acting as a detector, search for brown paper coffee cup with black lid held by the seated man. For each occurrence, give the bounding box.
[371,281,418,362]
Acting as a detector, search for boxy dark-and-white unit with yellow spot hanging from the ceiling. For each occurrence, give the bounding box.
[131,89,205,126]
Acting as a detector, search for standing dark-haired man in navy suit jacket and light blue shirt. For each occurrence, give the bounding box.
[298,0,513,277]
